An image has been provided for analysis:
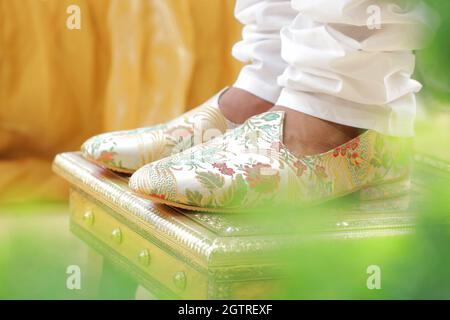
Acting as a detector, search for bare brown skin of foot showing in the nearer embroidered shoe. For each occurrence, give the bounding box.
[271,106,363,157]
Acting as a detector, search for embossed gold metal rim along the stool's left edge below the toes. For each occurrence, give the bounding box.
[53,153,216,263]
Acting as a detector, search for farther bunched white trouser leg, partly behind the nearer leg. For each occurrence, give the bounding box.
[233,0,298,103]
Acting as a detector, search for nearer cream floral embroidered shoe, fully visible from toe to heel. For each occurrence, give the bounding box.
[130,112,410,212]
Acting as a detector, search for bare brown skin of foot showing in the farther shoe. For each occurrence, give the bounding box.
[219,88,273,124]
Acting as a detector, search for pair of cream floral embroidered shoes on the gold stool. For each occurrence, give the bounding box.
[82,89,410,212]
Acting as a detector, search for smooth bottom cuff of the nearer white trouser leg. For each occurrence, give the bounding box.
[276,89,416,137]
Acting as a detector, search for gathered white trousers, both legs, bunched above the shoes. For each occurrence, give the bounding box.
[233,0,437,136]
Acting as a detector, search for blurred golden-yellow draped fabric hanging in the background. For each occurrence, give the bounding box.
[0,0,241,203]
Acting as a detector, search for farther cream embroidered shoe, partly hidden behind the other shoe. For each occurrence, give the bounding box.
[81,89,236,173]
